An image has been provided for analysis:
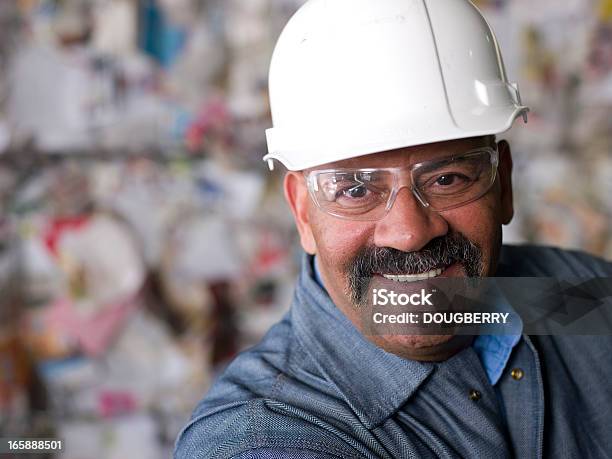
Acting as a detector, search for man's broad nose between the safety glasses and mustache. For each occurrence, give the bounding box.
[374,187,449,252]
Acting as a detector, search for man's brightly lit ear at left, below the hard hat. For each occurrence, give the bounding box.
[284,172,317,255]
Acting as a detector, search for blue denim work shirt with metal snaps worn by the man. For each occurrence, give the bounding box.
[175,247,612,459]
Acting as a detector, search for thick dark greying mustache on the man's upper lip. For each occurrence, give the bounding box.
[345,233,483,305]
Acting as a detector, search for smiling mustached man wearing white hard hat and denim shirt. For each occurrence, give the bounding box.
[175,0,612,459]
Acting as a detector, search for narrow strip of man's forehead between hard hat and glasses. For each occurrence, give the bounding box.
[309,137,495,170]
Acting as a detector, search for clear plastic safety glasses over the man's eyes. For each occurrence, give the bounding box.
[305,147,499,221]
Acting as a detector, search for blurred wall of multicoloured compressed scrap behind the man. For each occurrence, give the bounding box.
[0,0,612,459]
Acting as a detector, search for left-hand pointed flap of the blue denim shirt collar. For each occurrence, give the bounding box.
[291,255,435,429]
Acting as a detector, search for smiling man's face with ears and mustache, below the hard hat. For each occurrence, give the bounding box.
[285,137,513,361]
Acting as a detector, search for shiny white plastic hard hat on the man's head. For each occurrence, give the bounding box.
[264,0,529,170]
